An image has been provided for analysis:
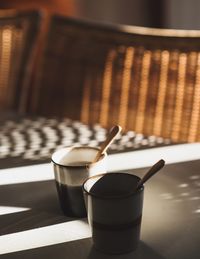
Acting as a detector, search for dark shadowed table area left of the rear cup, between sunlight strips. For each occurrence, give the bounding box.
[0,180,77,235]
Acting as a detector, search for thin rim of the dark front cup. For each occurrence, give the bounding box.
[82,172,144,200]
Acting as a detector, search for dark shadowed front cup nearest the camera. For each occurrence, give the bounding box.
[83,172,144,254]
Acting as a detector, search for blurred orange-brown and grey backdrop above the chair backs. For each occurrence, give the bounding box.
[0,0,200,29]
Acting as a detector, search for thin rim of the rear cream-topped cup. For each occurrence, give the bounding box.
[51,145,107,168]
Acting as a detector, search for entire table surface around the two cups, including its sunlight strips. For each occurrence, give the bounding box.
[0,143,200,259]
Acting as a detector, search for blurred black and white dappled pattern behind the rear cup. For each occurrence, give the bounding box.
[0,117,171,169]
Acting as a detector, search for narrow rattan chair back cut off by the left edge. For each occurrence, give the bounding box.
[0,10,41,112]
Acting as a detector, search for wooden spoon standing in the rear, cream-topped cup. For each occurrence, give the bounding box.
[93,125,122,163]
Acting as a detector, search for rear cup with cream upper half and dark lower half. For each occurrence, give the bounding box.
[51,146,107,218]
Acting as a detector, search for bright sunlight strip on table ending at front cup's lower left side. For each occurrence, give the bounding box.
[0,220,91,254]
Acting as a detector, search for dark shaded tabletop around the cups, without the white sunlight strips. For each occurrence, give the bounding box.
[0,160,200,259]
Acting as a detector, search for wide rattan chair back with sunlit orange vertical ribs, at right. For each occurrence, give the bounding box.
[31,16,200,142]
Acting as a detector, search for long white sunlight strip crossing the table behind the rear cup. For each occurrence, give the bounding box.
[0,143,200,185]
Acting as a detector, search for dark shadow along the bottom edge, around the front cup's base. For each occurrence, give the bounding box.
[1,238,166,259]
